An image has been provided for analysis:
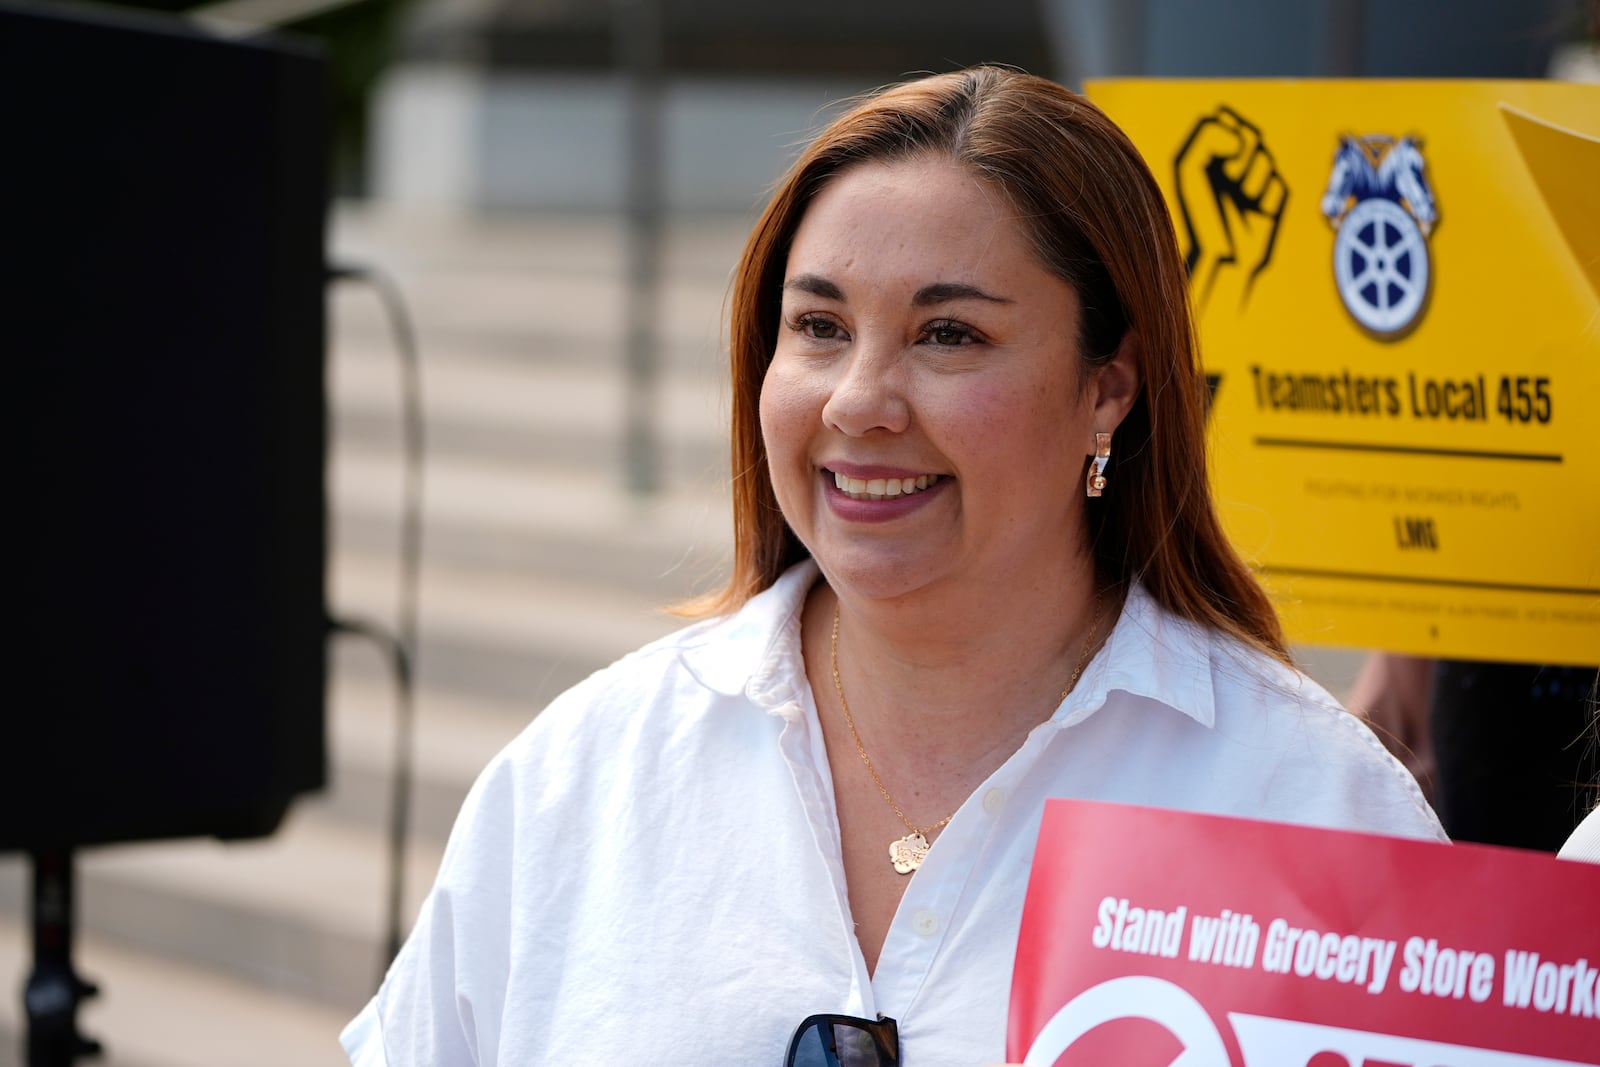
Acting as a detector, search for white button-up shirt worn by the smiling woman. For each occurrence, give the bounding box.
[342,563,1443,1067]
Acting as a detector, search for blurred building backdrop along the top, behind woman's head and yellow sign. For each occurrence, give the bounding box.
[371,0,1584,211]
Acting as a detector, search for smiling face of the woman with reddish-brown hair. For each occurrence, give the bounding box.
[760,158,1136,607]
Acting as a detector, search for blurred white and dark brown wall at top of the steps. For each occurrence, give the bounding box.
[373,0,1050,211]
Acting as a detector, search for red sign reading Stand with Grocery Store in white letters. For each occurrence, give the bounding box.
[1006,800,1600,1067]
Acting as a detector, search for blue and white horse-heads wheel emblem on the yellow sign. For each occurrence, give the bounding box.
[1322,134,1438,341]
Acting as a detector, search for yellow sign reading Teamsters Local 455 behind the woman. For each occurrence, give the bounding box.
[1090,80,1600,664]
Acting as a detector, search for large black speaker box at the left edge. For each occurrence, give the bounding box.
[0,0,328,849]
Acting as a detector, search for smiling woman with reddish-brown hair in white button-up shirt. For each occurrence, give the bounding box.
[344,67,1440,1067]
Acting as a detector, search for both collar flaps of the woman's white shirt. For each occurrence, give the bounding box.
[682,560,1216,726]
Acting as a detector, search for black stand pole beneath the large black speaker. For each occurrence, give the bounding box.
[22,848,102,1067]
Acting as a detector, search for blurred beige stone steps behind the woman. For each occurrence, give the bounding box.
[0,205,1355,1067]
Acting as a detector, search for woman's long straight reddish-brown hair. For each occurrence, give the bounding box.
[694,67,1288,662]
